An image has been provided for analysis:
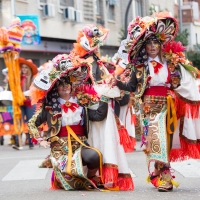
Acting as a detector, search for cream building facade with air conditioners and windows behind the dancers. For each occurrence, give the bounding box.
[0,0,177,85]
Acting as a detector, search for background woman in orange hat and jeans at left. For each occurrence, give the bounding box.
[13,58,38,150]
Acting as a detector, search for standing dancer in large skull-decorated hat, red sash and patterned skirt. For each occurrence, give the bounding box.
[112,12,184,191]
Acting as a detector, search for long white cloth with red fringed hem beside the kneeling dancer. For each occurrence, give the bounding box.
[88,83,134,190]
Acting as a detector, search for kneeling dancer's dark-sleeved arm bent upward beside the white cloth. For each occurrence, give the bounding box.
[88,96,109,121]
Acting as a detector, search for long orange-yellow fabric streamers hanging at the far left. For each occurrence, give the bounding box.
[3,51,25,134]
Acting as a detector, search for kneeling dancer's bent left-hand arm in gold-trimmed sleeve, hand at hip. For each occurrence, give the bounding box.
[28,107,47,139]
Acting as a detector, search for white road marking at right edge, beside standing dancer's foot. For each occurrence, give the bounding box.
[171,159,200,178]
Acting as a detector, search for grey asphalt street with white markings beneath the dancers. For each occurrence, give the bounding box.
[0,136,200,200]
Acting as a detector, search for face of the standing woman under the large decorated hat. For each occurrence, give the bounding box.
[146,40,160,58]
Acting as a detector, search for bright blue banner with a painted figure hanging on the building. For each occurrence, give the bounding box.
[18,15,41,45]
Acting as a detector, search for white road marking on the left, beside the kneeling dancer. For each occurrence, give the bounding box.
[2,160,49,181]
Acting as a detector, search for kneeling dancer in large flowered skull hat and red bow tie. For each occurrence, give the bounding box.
[28,54,108,190]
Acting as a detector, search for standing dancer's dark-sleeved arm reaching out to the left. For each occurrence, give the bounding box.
[116,71,137,92]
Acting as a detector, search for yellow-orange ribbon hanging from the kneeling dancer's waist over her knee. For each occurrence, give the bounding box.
[66,126,103,181]
